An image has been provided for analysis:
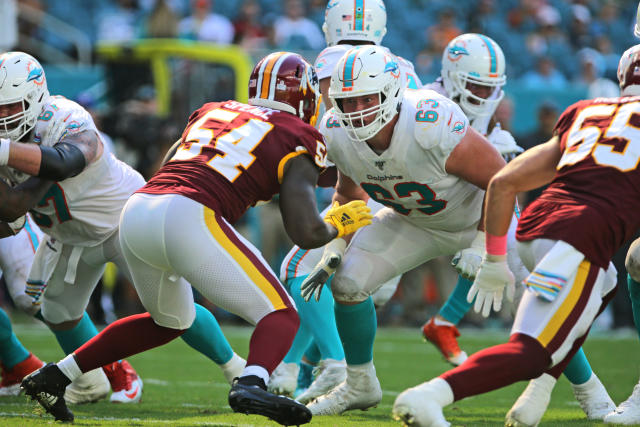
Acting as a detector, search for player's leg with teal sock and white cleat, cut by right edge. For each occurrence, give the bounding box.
[604,239,640,424]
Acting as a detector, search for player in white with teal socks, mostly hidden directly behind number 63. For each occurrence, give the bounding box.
[269,0,422,403]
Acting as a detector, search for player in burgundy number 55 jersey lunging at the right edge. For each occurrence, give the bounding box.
[393,45,640,426]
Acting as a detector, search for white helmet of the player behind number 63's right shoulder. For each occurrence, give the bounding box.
[441,33,507,120]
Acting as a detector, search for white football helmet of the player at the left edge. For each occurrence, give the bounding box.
[0,52,49,141]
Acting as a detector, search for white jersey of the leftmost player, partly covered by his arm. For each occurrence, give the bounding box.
[0,96,145,246]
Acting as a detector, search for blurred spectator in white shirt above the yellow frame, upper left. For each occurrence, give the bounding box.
[178,0,234,44]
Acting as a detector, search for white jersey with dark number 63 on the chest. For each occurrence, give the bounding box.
[320,89,484,231]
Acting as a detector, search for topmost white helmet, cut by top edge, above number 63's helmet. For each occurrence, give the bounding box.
[322,0,387,46]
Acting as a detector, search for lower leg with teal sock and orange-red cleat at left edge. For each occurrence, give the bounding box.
[0,309,44,396]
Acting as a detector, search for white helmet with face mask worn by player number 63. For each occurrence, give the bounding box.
[329,45,404,141]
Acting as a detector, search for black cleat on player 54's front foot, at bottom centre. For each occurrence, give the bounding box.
[229,376,311,426]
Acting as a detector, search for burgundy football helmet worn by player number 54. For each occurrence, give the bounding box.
[249,52,320,126]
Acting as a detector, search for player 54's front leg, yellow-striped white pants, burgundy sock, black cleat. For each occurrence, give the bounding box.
[158,196,311,424]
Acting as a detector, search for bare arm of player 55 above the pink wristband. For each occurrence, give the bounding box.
[485,136,562,236]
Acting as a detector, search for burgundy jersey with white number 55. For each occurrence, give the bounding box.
[517,96,640,268]
